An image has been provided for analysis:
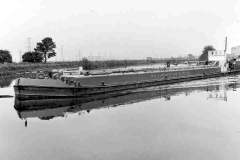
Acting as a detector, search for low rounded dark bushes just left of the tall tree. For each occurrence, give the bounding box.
[22,52,43,63]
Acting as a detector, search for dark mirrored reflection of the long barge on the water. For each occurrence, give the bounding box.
[14,84,233,126]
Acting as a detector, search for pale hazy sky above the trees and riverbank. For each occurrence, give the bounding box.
[0,0,240,61]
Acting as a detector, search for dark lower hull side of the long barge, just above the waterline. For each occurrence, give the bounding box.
[14,71,240,99]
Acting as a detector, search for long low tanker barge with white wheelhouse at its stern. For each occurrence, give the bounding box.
[14,38,240,99]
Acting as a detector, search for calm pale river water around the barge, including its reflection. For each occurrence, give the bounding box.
[0,76,240,160]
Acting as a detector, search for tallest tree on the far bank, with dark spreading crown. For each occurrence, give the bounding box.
[34,37,56,63]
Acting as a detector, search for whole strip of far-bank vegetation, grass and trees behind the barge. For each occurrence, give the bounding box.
[0,37,211,75]
